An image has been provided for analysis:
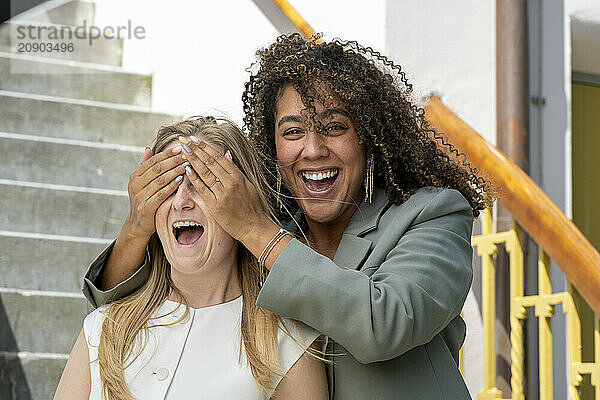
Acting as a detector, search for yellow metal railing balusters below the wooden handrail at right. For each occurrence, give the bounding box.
[472,210,600,400]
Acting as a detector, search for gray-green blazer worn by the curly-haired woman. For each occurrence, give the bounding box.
[83,187,473,400]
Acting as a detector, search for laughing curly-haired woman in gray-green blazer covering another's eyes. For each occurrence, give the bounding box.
[86,35,490,400]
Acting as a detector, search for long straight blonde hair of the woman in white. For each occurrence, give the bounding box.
[98,117,281,400]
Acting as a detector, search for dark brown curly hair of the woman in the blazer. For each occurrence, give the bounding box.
[242,34,491,216]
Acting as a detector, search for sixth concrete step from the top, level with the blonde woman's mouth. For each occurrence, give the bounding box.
[0,179,129,239]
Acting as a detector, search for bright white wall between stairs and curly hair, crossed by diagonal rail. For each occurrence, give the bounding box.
[95,0,385,123]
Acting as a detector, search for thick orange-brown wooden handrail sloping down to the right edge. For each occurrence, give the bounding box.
[425,96,600,315]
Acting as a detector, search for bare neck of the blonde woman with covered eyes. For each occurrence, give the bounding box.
[169,249,242,308]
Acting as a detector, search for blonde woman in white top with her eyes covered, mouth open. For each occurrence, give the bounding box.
[55,117,328,400]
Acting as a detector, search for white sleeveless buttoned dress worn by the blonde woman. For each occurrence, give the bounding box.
[84,296,319,400]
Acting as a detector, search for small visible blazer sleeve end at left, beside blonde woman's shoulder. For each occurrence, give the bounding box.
[81,241,150,308]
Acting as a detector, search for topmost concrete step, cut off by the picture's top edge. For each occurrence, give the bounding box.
[19,0,96,25]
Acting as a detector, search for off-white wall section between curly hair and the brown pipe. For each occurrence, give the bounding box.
[386,0,496,143]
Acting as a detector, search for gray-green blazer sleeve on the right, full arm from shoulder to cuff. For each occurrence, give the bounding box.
[257,190,473,363]
